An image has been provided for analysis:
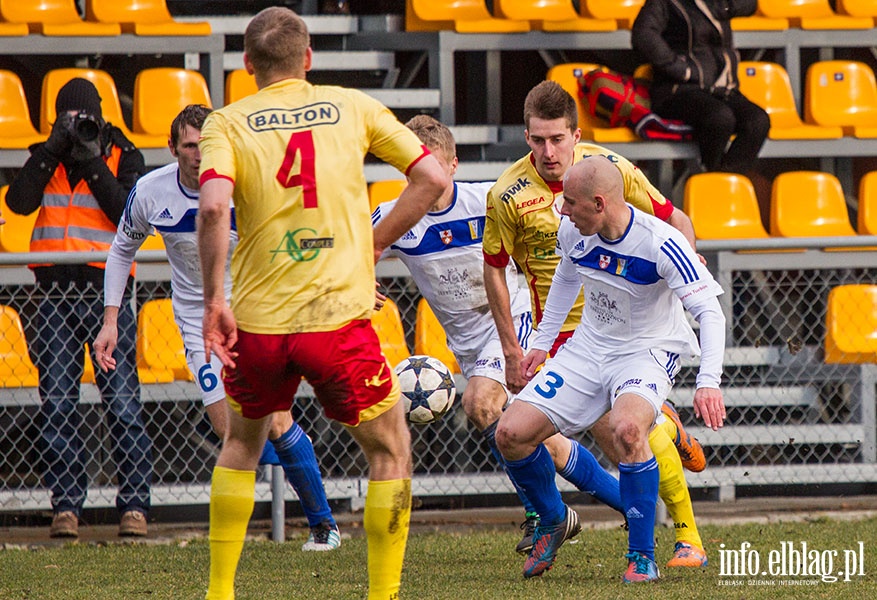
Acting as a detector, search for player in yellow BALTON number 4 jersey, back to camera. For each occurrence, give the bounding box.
[198,7,447,600]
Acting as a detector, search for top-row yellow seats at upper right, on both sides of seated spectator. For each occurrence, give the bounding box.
[405,0,877,33]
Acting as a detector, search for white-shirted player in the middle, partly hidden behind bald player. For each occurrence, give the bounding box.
[372,115,621,553]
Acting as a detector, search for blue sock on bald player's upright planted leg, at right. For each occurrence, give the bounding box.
[618,456,658,560]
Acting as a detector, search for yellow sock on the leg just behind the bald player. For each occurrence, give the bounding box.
[649,426,703,548]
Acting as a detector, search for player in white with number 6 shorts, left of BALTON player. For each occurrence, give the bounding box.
[94,105,341,551]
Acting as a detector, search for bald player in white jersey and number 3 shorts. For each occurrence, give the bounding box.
[496,156,725,583]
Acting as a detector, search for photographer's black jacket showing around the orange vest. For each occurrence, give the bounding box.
[6,124,146,289]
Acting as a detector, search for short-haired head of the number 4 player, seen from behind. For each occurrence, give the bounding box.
[244,6,311,77]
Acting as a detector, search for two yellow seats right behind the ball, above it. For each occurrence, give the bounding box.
[372,298,460,373]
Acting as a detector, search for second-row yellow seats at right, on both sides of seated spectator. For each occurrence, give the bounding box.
[546,59,877,143]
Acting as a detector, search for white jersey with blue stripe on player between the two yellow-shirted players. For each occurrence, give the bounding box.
[372,183,530,354]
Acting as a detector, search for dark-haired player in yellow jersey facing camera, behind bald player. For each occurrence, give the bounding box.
[483,81,707,567]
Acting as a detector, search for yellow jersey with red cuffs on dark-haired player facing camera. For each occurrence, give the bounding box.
[483,143,673,331]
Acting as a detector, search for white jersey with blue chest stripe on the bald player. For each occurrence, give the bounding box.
[533,205,722,357]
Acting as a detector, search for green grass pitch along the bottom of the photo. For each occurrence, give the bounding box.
[0,519,877,600]
